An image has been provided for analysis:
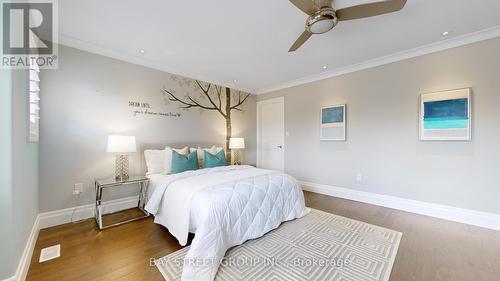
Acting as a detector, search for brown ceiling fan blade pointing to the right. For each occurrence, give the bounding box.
[335,0,406,20]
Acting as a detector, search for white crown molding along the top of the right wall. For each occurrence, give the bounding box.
[255,26,500,95]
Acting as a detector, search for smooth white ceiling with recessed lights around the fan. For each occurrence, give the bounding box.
[59,0,500,93]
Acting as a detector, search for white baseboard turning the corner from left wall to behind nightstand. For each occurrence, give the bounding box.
[2,196,138,281]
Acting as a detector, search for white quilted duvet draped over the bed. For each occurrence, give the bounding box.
[146,166,306,281]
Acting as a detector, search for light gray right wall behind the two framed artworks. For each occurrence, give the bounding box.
[258,38,500,214]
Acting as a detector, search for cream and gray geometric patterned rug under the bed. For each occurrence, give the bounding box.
[156,209,402,281]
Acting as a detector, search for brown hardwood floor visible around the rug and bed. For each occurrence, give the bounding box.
[27,192,500,281]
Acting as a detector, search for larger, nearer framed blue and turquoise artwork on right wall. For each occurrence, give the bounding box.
[419,88,472,141]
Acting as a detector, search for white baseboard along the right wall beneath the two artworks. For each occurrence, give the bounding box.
[300,181,500,230]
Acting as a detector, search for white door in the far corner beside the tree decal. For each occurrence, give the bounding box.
[257,97,285,171]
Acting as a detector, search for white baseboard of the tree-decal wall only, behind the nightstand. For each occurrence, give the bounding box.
[38,196,138,229]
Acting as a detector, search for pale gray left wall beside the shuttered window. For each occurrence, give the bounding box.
[0,70,38,279]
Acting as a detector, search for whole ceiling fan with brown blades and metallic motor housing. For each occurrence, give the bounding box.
[288,0,406,52]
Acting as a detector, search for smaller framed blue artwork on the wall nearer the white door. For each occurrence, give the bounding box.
[320,104,346,141]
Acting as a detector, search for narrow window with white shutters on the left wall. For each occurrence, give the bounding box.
[28,63,40,142]
